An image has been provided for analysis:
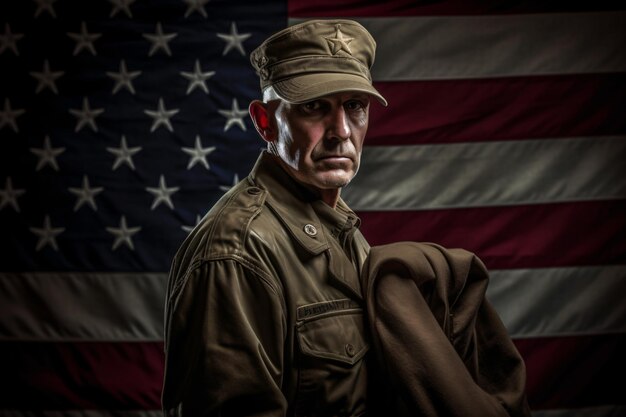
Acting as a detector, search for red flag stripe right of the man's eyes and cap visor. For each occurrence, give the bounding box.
[366,73,626,146]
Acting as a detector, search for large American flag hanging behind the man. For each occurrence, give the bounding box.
[0,0,626,417]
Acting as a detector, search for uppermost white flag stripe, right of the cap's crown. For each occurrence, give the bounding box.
[289,11,626,81]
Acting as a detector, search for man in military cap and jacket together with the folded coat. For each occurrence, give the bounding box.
[162,20,530,417]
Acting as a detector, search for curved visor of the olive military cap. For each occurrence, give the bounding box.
[272,73,387,106]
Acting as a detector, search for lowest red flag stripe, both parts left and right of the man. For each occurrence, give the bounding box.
[0,334,626,411]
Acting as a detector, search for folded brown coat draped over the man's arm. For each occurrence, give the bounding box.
[362,242,530,417]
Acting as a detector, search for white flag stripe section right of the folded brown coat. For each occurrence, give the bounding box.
[487,265,626,338]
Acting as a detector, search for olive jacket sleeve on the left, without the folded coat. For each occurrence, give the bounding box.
[162,259,287,417]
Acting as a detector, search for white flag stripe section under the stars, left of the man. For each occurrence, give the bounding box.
[0,272,167,342]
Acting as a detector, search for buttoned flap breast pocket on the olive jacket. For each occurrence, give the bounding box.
[296,300,369,416]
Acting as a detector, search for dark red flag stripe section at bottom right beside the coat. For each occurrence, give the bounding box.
[514,333,626,410]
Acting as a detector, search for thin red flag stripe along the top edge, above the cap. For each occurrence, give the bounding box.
[287,0,616,17]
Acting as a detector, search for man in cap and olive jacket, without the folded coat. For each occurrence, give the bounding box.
[163,20,386,416]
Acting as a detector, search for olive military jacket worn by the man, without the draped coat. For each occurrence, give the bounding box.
[162,153,369,417]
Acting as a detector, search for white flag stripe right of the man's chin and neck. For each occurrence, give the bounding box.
[342,136,626,211]
